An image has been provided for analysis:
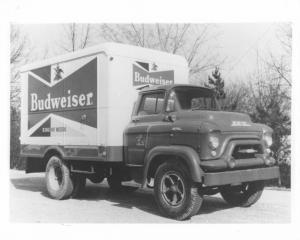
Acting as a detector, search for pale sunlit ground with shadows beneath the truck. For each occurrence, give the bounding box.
[10,170,291,223]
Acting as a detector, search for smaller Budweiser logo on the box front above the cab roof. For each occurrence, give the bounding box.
[133,62,174,86]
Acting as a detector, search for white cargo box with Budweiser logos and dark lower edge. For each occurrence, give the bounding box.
[20,43,188,161]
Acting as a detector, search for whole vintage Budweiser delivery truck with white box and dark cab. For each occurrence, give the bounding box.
[20,43,279,220]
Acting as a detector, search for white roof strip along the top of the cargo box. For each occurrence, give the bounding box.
[21,42,187,72]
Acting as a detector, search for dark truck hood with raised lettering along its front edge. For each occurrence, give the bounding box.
[177,110,272,132]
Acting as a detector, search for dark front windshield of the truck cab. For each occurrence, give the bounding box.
[174,87,219,111]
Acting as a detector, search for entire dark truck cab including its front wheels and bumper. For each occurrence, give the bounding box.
[124,84,279,219]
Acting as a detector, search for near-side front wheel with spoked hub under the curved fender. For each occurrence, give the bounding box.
[154,162,203,220]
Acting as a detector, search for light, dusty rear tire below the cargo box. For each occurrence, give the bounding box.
[46,156,74,200]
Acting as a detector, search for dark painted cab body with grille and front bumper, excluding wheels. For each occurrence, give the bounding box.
[124,85,279,186]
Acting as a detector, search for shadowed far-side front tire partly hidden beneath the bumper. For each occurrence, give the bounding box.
[220,181,264,207]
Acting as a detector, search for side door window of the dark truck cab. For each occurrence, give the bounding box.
[138,92,165,116]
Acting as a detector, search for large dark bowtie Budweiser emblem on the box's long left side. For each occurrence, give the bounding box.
[28,58,97,129]
